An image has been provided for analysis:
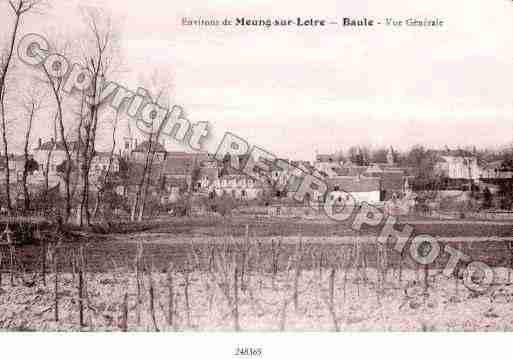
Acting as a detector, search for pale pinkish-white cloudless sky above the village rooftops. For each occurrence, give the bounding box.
[0,0,513,160]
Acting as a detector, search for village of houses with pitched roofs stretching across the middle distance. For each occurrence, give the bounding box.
[0,137,513,220]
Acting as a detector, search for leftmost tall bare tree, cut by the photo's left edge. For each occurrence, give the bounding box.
[0,0,43,213]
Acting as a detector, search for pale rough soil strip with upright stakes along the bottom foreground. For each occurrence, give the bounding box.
[0,268,513,331]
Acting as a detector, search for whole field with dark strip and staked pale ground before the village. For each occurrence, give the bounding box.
[0,219,513,331]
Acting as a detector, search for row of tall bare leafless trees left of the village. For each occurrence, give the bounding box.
[0,0,178,226]
